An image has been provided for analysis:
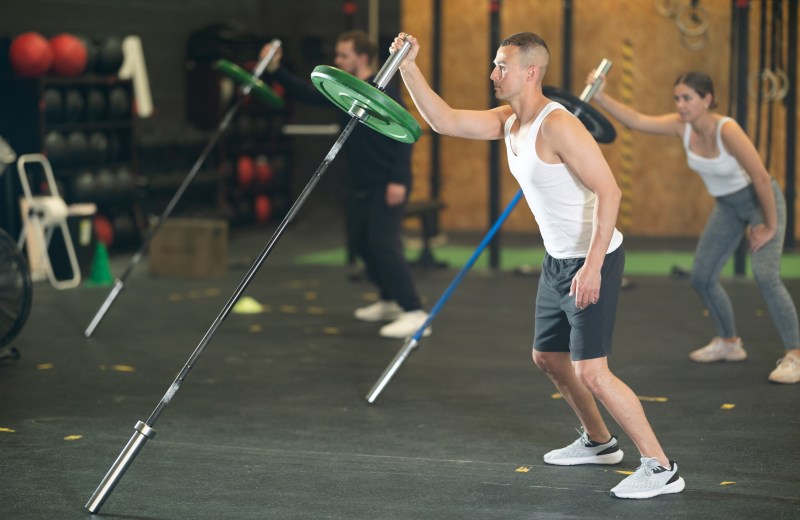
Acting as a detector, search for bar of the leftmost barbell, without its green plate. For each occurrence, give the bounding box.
[83,39,280,338]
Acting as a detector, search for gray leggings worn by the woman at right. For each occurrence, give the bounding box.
[691,179,800,350]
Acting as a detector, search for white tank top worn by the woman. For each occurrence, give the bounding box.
[683,117,752,197]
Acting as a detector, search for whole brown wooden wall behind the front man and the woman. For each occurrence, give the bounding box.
[401,0,800,237]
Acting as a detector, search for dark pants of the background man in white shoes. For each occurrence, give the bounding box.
[347,187,422,311]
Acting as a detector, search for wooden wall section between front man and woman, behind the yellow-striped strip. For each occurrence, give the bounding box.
[572,0,731,236]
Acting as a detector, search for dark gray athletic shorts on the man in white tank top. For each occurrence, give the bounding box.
[533,245,625,361]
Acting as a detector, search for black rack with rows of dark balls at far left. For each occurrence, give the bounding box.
[0,75,138,250]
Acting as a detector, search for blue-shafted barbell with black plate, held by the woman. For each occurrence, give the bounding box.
[366,59,617,404]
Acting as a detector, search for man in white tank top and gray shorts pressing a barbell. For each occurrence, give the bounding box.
[392,29,684,498]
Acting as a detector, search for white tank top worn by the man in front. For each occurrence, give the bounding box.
[505,101,622,258]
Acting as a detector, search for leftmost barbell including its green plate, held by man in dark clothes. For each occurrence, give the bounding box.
[83,39,283,340]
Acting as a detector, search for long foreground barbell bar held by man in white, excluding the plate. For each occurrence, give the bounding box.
[85,37,418,513]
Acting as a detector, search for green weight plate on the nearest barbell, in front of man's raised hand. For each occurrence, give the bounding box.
[311,65,422,143]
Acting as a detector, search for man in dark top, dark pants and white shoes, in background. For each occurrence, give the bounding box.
[261,31,430,338]
